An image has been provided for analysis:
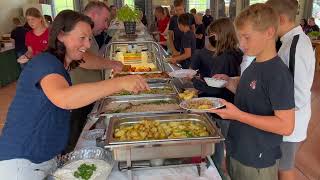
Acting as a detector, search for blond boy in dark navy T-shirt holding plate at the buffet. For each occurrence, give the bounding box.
[212,3,295,180]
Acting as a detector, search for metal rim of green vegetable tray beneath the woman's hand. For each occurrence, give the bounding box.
[109,82,179,98]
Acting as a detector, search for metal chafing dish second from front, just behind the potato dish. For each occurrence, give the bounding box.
[90,95,181,117]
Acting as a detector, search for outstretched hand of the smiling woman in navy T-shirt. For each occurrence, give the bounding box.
[118,75,150,93]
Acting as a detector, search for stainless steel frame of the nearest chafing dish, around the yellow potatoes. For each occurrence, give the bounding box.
[100,112,224,161]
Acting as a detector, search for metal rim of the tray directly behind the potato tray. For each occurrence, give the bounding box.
[95,95,181,117]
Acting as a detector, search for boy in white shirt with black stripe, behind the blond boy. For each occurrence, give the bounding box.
[266,0,315,180]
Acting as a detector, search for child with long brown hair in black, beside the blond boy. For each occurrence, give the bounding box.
[190,18,243,173]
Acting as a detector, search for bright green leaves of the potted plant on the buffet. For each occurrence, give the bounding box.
[117,5,141,22]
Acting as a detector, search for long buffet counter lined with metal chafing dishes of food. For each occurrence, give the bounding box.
[76,32,224,180]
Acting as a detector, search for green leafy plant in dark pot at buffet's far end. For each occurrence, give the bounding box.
[117,5,140,34]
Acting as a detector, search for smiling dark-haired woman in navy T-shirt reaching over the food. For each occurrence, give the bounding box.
[0,10,149,180]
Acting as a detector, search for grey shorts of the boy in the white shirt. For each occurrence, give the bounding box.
[279,142,299,171]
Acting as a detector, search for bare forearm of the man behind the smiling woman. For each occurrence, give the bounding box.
[80,51,123,72]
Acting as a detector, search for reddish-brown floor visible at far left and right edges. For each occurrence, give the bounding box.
[0,72,320,180]
